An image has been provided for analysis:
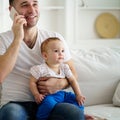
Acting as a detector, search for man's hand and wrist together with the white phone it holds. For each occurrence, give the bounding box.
[10,7,27,40]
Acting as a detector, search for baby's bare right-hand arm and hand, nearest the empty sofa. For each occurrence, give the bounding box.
[68,76,85,105]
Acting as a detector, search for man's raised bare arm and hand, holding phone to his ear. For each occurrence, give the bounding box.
[0,15,26,83]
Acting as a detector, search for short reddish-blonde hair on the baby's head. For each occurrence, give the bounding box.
[41,37,61,53]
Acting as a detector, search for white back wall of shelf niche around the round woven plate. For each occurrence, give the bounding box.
[76,10,120,40]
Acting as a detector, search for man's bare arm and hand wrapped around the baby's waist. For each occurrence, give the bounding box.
[38,59,77,94]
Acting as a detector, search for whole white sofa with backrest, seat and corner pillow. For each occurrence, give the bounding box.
[69,47,120,120]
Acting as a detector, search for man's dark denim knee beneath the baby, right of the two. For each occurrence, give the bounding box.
[49,103,85,120]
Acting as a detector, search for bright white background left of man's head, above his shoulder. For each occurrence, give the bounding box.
[0,0,12,33]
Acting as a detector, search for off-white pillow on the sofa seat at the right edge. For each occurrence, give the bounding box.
[113,82,120,106]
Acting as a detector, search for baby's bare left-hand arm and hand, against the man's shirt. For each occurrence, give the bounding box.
[30,76,45,104]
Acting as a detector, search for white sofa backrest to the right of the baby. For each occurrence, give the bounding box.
[66,48,120,105]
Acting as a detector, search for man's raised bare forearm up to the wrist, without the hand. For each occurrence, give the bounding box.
[0,39,20,83]
